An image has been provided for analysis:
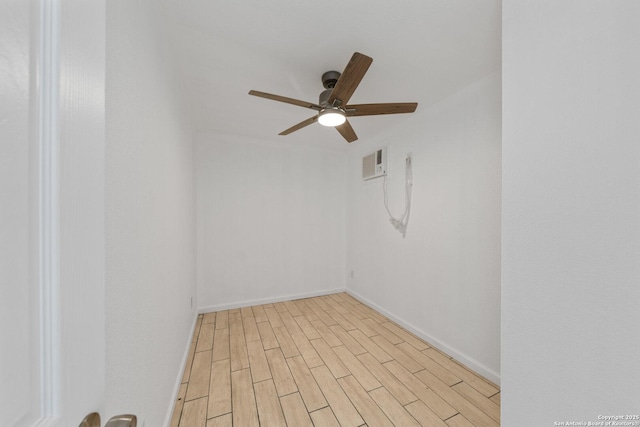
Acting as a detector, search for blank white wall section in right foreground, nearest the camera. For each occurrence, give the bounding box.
[502,0,640,426]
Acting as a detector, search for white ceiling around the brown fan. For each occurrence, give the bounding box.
[164,0,501,149]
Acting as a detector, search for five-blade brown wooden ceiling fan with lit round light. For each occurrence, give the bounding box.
[249,52,418,142]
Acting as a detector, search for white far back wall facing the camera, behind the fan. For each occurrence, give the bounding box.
[197,134,346,310]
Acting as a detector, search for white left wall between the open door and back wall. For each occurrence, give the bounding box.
[105,0,197,427]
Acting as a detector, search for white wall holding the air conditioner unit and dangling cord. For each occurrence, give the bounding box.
[347,73,501,382]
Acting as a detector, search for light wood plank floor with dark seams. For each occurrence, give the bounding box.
[171,293,500,427]
